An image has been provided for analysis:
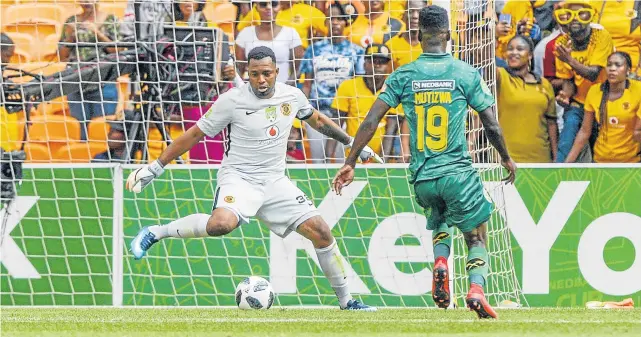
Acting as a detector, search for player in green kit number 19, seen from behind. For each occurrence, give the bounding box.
[332,5,516,318]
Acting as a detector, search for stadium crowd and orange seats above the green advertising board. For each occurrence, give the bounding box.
[0,0,641,163]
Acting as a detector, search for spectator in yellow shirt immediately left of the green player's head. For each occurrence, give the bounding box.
[385,0,426,70]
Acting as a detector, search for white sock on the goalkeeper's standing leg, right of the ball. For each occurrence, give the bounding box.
[316,240,352,308]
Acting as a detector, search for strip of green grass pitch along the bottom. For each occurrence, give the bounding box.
[0,307,641,337]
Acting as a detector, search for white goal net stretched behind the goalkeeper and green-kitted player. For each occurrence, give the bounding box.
[0,0,525,307]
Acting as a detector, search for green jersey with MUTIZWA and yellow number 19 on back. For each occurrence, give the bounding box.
[378,53,494,183]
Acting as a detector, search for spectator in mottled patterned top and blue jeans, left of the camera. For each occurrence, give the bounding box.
[58,0,119,140]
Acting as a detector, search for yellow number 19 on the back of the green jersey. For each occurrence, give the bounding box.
[414,105,449,152]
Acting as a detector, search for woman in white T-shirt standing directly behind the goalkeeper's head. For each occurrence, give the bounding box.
[236,1,305,85]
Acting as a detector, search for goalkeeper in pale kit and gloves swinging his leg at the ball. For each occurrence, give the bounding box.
[127,47,380,311]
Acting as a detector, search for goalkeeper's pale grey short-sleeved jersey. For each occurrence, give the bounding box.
[197,83,313,183]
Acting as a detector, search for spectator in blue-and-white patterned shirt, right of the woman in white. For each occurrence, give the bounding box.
[300,3,365,163]
